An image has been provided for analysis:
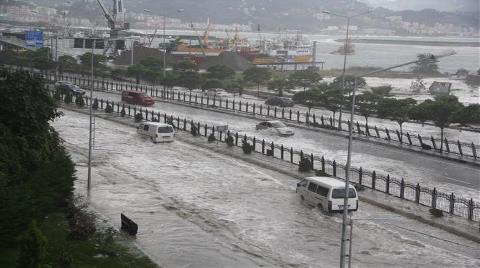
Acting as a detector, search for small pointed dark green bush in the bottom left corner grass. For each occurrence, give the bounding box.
[17,221,47,267]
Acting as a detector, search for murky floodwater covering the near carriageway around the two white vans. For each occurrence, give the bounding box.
[53,111,480,267]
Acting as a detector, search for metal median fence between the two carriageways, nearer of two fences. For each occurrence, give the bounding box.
[64,93,480,221]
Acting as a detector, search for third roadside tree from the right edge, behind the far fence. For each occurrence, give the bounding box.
[378,98,417,142]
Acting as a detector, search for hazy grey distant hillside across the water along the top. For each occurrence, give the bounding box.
[4,0,480,32]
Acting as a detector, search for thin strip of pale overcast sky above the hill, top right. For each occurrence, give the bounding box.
[359,0,479,11]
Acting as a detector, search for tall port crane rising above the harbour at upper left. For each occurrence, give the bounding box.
[97,0,130,56]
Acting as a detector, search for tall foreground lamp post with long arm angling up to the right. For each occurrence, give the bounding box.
[340,50,456,268]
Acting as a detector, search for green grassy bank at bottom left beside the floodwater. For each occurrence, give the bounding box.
[0,213,158,267]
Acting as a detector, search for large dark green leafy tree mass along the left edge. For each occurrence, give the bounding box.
[0,72,74,247]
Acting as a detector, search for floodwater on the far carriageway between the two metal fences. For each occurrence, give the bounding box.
[90,92,480,198]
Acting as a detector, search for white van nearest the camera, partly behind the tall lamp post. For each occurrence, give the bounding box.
[296,177,358,212]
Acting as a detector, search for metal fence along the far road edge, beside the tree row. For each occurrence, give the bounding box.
[3,65,480,160]
